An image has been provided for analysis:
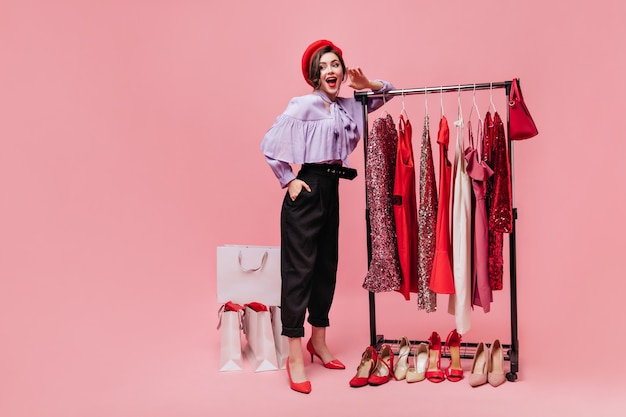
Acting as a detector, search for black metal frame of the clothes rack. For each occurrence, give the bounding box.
[354,79,519,381]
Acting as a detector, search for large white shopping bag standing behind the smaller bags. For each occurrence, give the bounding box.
[217,245,281,306]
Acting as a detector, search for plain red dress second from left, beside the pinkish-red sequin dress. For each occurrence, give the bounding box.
[393,115,418,300]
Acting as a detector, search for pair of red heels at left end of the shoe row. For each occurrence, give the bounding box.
[350,340,394,388]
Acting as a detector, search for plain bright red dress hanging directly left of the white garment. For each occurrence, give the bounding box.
[430,116,454,294]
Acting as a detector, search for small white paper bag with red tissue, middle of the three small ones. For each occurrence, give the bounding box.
[243,303,278,372]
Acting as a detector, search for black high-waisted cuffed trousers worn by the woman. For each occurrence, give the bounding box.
[280,167,339,337]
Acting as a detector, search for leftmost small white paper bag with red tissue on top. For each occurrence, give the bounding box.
[217,303,243,371]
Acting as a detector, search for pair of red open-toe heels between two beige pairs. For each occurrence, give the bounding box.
[425,329,463,382]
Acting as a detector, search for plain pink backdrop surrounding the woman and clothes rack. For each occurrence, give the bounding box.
[0,0,626,417]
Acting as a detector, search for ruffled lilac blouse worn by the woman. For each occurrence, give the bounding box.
[261,80,393,187]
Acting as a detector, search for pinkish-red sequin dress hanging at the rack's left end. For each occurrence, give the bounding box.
[363,114,402,293]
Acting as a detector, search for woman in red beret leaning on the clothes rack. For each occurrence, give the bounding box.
[261,40,393,394]
